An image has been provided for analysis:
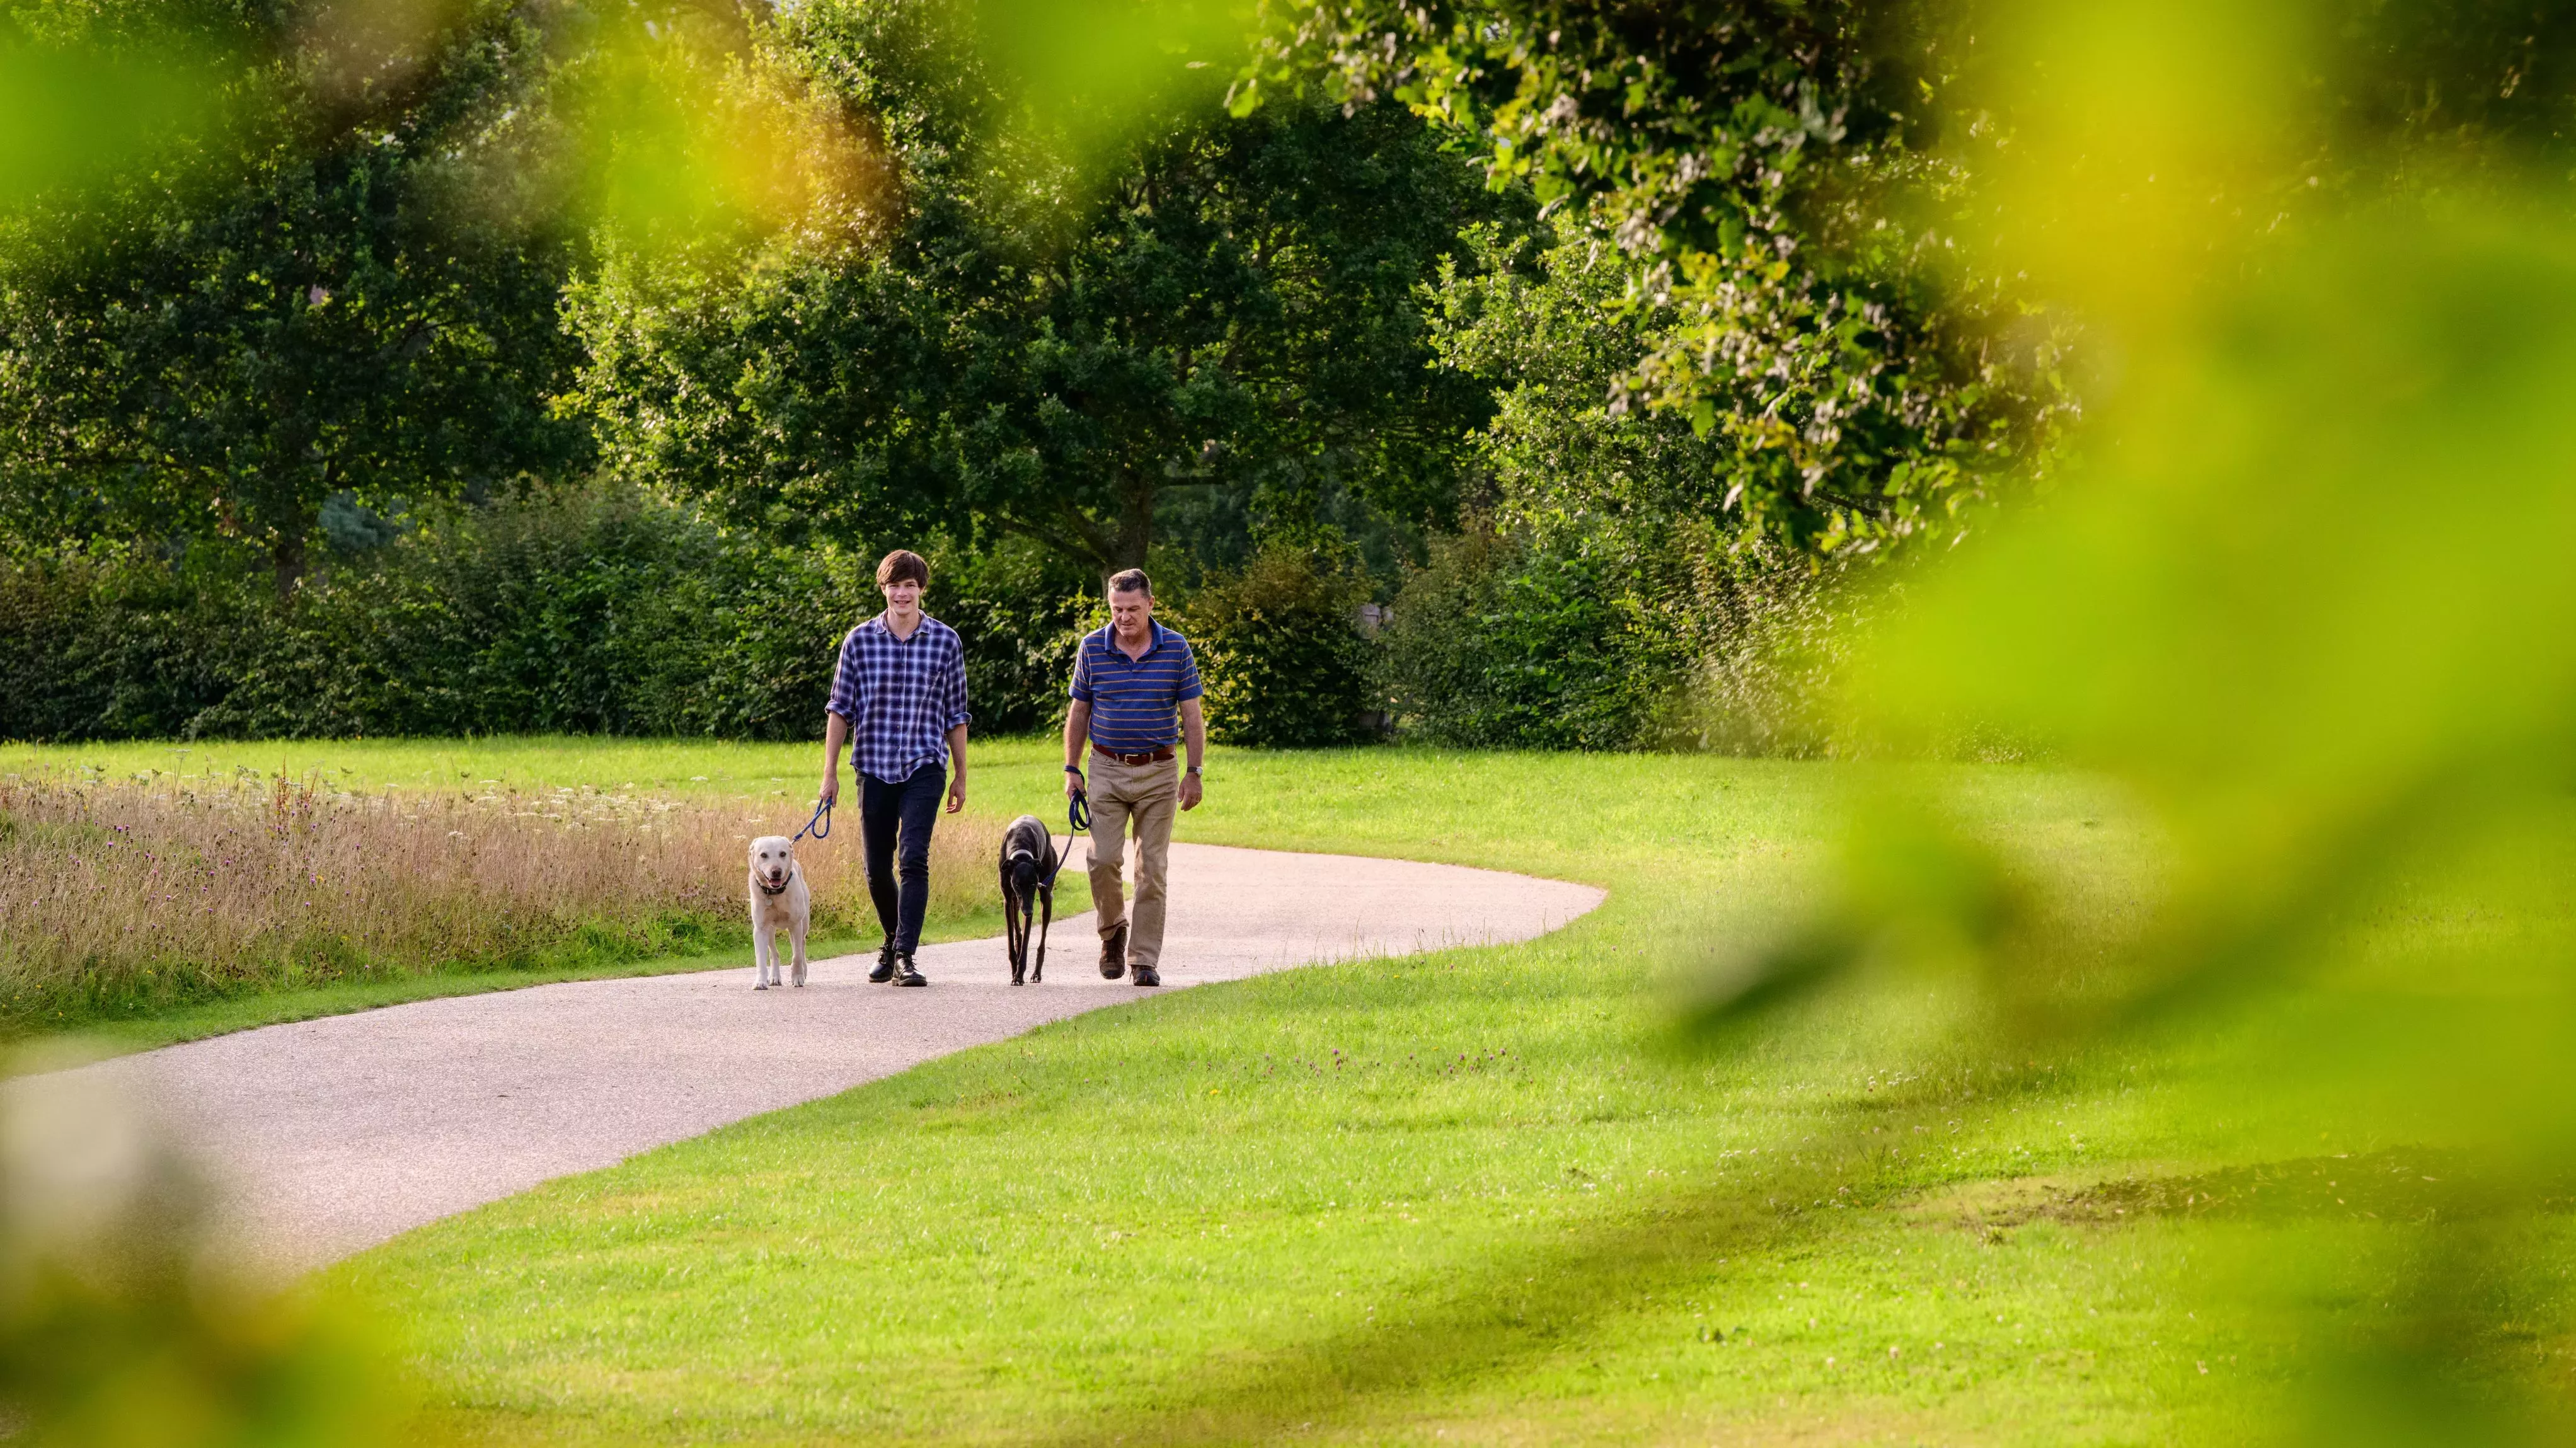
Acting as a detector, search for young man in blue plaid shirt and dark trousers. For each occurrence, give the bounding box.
[822,549,969,984]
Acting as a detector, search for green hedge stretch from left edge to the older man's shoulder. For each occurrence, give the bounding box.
[0,487,1090,740]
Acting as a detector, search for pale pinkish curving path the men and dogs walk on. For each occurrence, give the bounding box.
[43,845,1602,1268]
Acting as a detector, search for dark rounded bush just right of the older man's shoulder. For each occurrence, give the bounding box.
[1180,541,1371,750]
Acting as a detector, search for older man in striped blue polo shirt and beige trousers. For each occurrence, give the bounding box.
[1064,570,1208,987]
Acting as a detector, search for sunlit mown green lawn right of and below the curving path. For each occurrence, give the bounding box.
[272,750,2272,1443]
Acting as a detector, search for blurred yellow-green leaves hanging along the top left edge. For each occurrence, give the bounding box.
[0,0,1250,244]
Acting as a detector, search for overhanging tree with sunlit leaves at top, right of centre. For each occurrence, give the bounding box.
[1234,0,2066,551]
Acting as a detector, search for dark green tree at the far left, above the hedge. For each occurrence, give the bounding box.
[0,0,585,595]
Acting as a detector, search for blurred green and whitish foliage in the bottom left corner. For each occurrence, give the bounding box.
[0,1056,405,1448]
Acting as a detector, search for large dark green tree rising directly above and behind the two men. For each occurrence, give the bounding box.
[577,5,1499,572]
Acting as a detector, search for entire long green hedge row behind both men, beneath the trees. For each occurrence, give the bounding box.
[0,490,1842,752]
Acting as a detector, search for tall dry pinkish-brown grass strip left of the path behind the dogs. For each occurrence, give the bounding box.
[0,773,999,1028]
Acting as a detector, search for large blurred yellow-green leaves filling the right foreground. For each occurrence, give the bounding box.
[1713,5,2576,1443]
